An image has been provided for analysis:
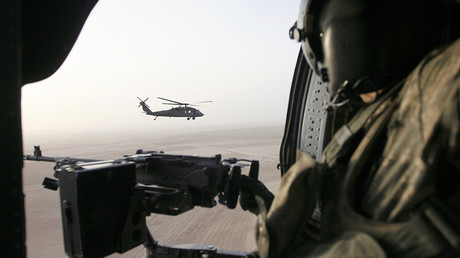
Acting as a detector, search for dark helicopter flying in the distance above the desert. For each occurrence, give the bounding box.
[137,97,212,120]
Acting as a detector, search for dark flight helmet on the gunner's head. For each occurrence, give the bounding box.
[289,0,460,100]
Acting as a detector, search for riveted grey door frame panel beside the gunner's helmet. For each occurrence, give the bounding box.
[279,49,330,175]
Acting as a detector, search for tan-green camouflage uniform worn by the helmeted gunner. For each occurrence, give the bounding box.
[257,40,460,257]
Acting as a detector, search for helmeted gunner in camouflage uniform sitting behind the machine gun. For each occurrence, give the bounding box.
[240,0,460,257]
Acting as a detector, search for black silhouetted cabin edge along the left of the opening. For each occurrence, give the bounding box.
[0,0,97,257]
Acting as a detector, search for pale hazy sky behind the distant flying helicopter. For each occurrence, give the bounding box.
[22,0,300,136]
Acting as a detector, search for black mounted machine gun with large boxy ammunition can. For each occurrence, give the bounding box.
[24,146,259,257]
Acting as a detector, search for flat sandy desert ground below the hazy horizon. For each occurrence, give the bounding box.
[23,127,283,258]
